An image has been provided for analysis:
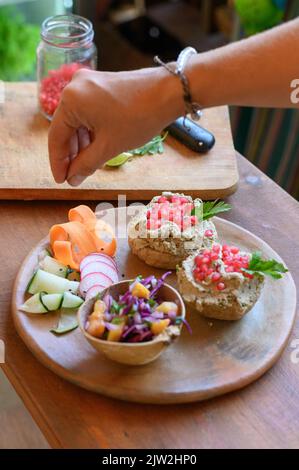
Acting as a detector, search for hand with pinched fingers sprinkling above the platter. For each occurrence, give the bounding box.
[48,68,184,186]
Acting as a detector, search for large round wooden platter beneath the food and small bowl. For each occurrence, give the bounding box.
[12,209,296,404]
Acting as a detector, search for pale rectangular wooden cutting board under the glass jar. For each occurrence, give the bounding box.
[0,83,238,200]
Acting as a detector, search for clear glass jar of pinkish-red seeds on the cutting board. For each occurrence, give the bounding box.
[37,15,97,120]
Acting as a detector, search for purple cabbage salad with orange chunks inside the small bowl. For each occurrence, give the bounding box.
[88,271,189,343]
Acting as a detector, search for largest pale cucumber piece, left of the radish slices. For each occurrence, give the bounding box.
[27,269,79,294]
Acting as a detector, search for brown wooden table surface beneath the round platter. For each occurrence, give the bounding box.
[0,153,299,448]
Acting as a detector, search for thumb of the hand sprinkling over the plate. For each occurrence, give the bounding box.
[67,138,102,186]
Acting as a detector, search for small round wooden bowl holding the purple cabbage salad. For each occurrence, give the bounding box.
[78,281,186,365]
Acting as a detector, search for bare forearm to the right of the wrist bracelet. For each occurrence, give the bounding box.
[164,19,299,114]
